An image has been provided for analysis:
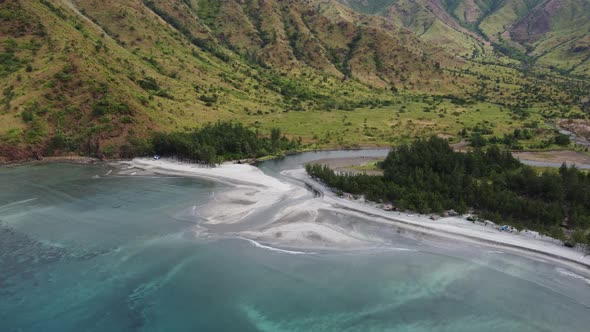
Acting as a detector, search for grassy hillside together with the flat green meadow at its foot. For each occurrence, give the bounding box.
[0,0,587,160]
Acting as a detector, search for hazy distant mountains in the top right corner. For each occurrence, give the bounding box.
[341,0,590,76]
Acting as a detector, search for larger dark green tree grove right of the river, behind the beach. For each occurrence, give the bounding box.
[307,137,590,244]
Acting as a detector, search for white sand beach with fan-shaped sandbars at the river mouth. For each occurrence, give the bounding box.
[122,159,590,276]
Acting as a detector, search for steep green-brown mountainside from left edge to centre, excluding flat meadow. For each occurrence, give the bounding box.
[0,0,451,158]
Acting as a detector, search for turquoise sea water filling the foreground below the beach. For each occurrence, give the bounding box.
[0,156,590,332]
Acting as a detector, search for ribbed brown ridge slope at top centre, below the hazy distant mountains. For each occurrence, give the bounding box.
[168,0,448,86]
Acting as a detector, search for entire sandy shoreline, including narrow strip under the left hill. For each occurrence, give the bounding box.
[4,157,590,275]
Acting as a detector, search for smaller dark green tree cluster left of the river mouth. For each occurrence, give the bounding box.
[151,122,301,164]
